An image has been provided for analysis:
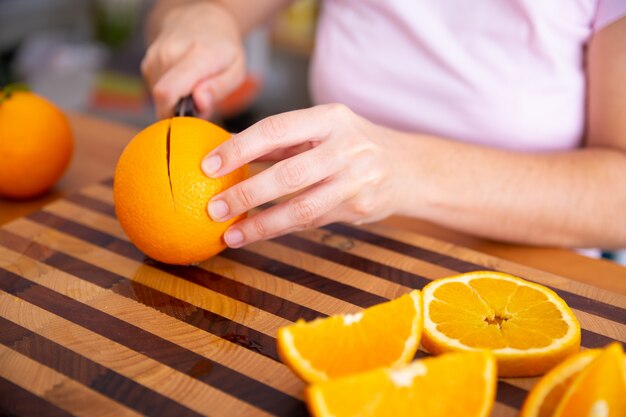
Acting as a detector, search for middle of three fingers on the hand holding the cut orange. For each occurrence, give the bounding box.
[208,143,343,221]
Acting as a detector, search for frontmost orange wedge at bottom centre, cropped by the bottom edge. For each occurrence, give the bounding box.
[305,351,497,417]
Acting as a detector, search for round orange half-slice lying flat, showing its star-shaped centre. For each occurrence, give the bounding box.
[422,271,580,377]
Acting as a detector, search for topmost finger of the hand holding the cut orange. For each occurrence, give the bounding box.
[202,105,342,178]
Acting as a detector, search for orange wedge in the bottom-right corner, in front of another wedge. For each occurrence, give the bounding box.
[554,343,626,417]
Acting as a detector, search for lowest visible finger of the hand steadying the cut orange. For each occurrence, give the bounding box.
[224,176,353,248]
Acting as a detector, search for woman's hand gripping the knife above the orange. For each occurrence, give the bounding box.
[141,2,245,118]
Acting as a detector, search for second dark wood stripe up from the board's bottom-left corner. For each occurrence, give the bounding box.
[0,317,201,416]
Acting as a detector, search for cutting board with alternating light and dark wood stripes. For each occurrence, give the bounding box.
[0,181,626,417]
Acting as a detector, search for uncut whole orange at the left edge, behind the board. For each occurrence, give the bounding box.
[0,90,74,199]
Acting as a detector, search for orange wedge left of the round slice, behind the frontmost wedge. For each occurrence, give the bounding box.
[278,290,422,382]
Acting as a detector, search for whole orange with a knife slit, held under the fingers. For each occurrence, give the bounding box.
[113,117,248,265]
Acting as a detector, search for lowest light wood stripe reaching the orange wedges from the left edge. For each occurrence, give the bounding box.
[0,242,303,398]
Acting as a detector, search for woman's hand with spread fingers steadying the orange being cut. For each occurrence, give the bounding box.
[202,104,407,247]
